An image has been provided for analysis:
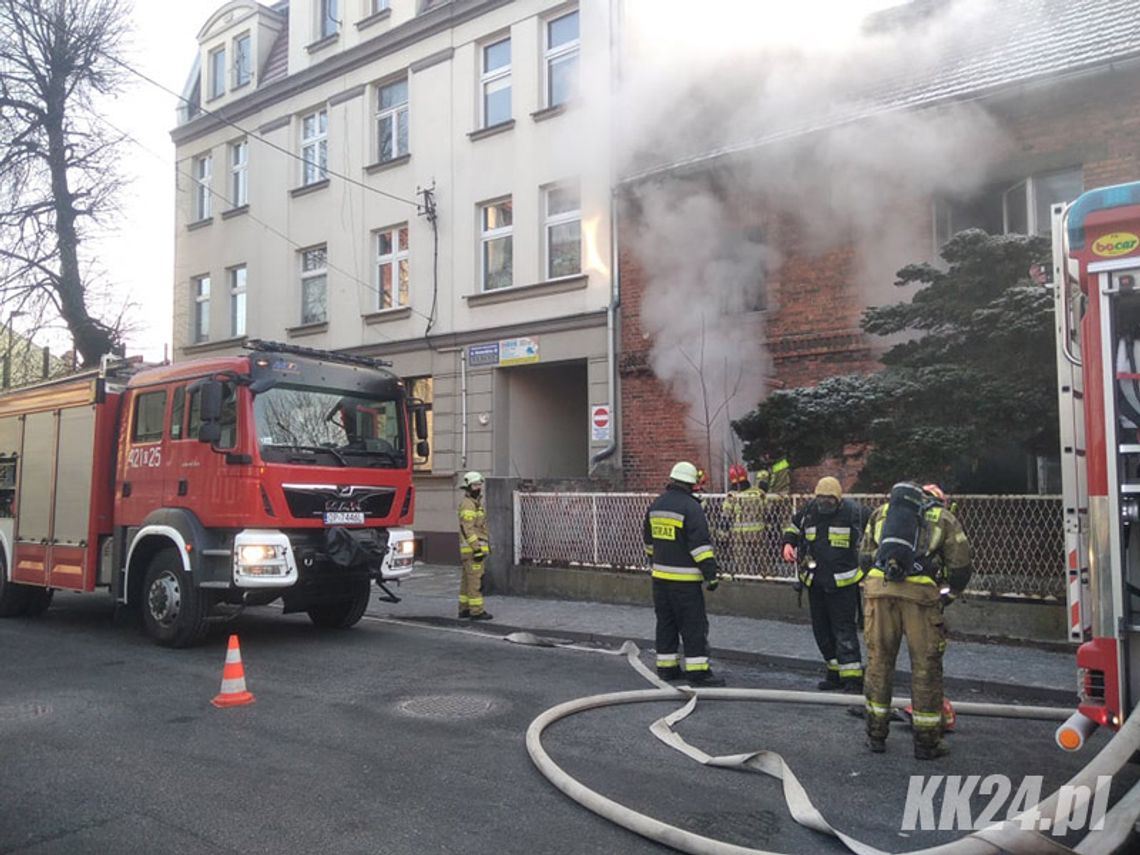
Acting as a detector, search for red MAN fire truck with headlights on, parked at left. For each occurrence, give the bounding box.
[0,342,428,646]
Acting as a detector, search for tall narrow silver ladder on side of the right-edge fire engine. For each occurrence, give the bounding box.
[1052,204,1092,644]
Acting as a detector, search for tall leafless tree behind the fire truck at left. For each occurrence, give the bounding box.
[0,0,129,365]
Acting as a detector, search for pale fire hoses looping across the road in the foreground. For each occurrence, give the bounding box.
[522,633,1140,855]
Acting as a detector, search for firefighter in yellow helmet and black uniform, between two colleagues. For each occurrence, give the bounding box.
[783,475,866,693]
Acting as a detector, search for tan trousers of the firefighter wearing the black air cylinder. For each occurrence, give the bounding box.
[863,577,946,746]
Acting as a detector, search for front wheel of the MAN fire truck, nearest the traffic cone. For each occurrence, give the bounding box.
[139,551,210,648]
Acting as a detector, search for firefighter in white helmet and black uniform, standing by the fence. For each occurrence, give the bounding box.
[643,461,724,686]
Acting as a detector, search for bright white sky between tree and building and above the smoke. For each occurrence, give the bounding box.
[95,0,897,360]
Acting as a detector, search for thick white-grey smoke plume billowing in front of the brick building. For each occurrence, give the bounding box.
[617,0,1016,478]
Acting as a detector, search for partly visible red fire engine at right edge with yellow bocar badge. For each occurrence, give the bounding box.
[1053,182,1140,750]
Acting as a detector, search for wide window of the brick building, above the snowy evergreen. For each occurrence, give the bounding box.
[934,166,1084,250]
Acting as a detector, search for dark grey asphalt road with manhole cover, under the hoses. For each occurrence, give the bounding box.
[0,595,1137,855]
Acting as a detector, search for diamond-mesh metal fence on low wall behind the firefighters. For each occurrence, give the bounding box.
[514,492,1065,600]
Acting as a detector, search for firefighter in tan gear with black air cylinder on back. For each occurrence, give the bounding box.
[860,482,972,760]
